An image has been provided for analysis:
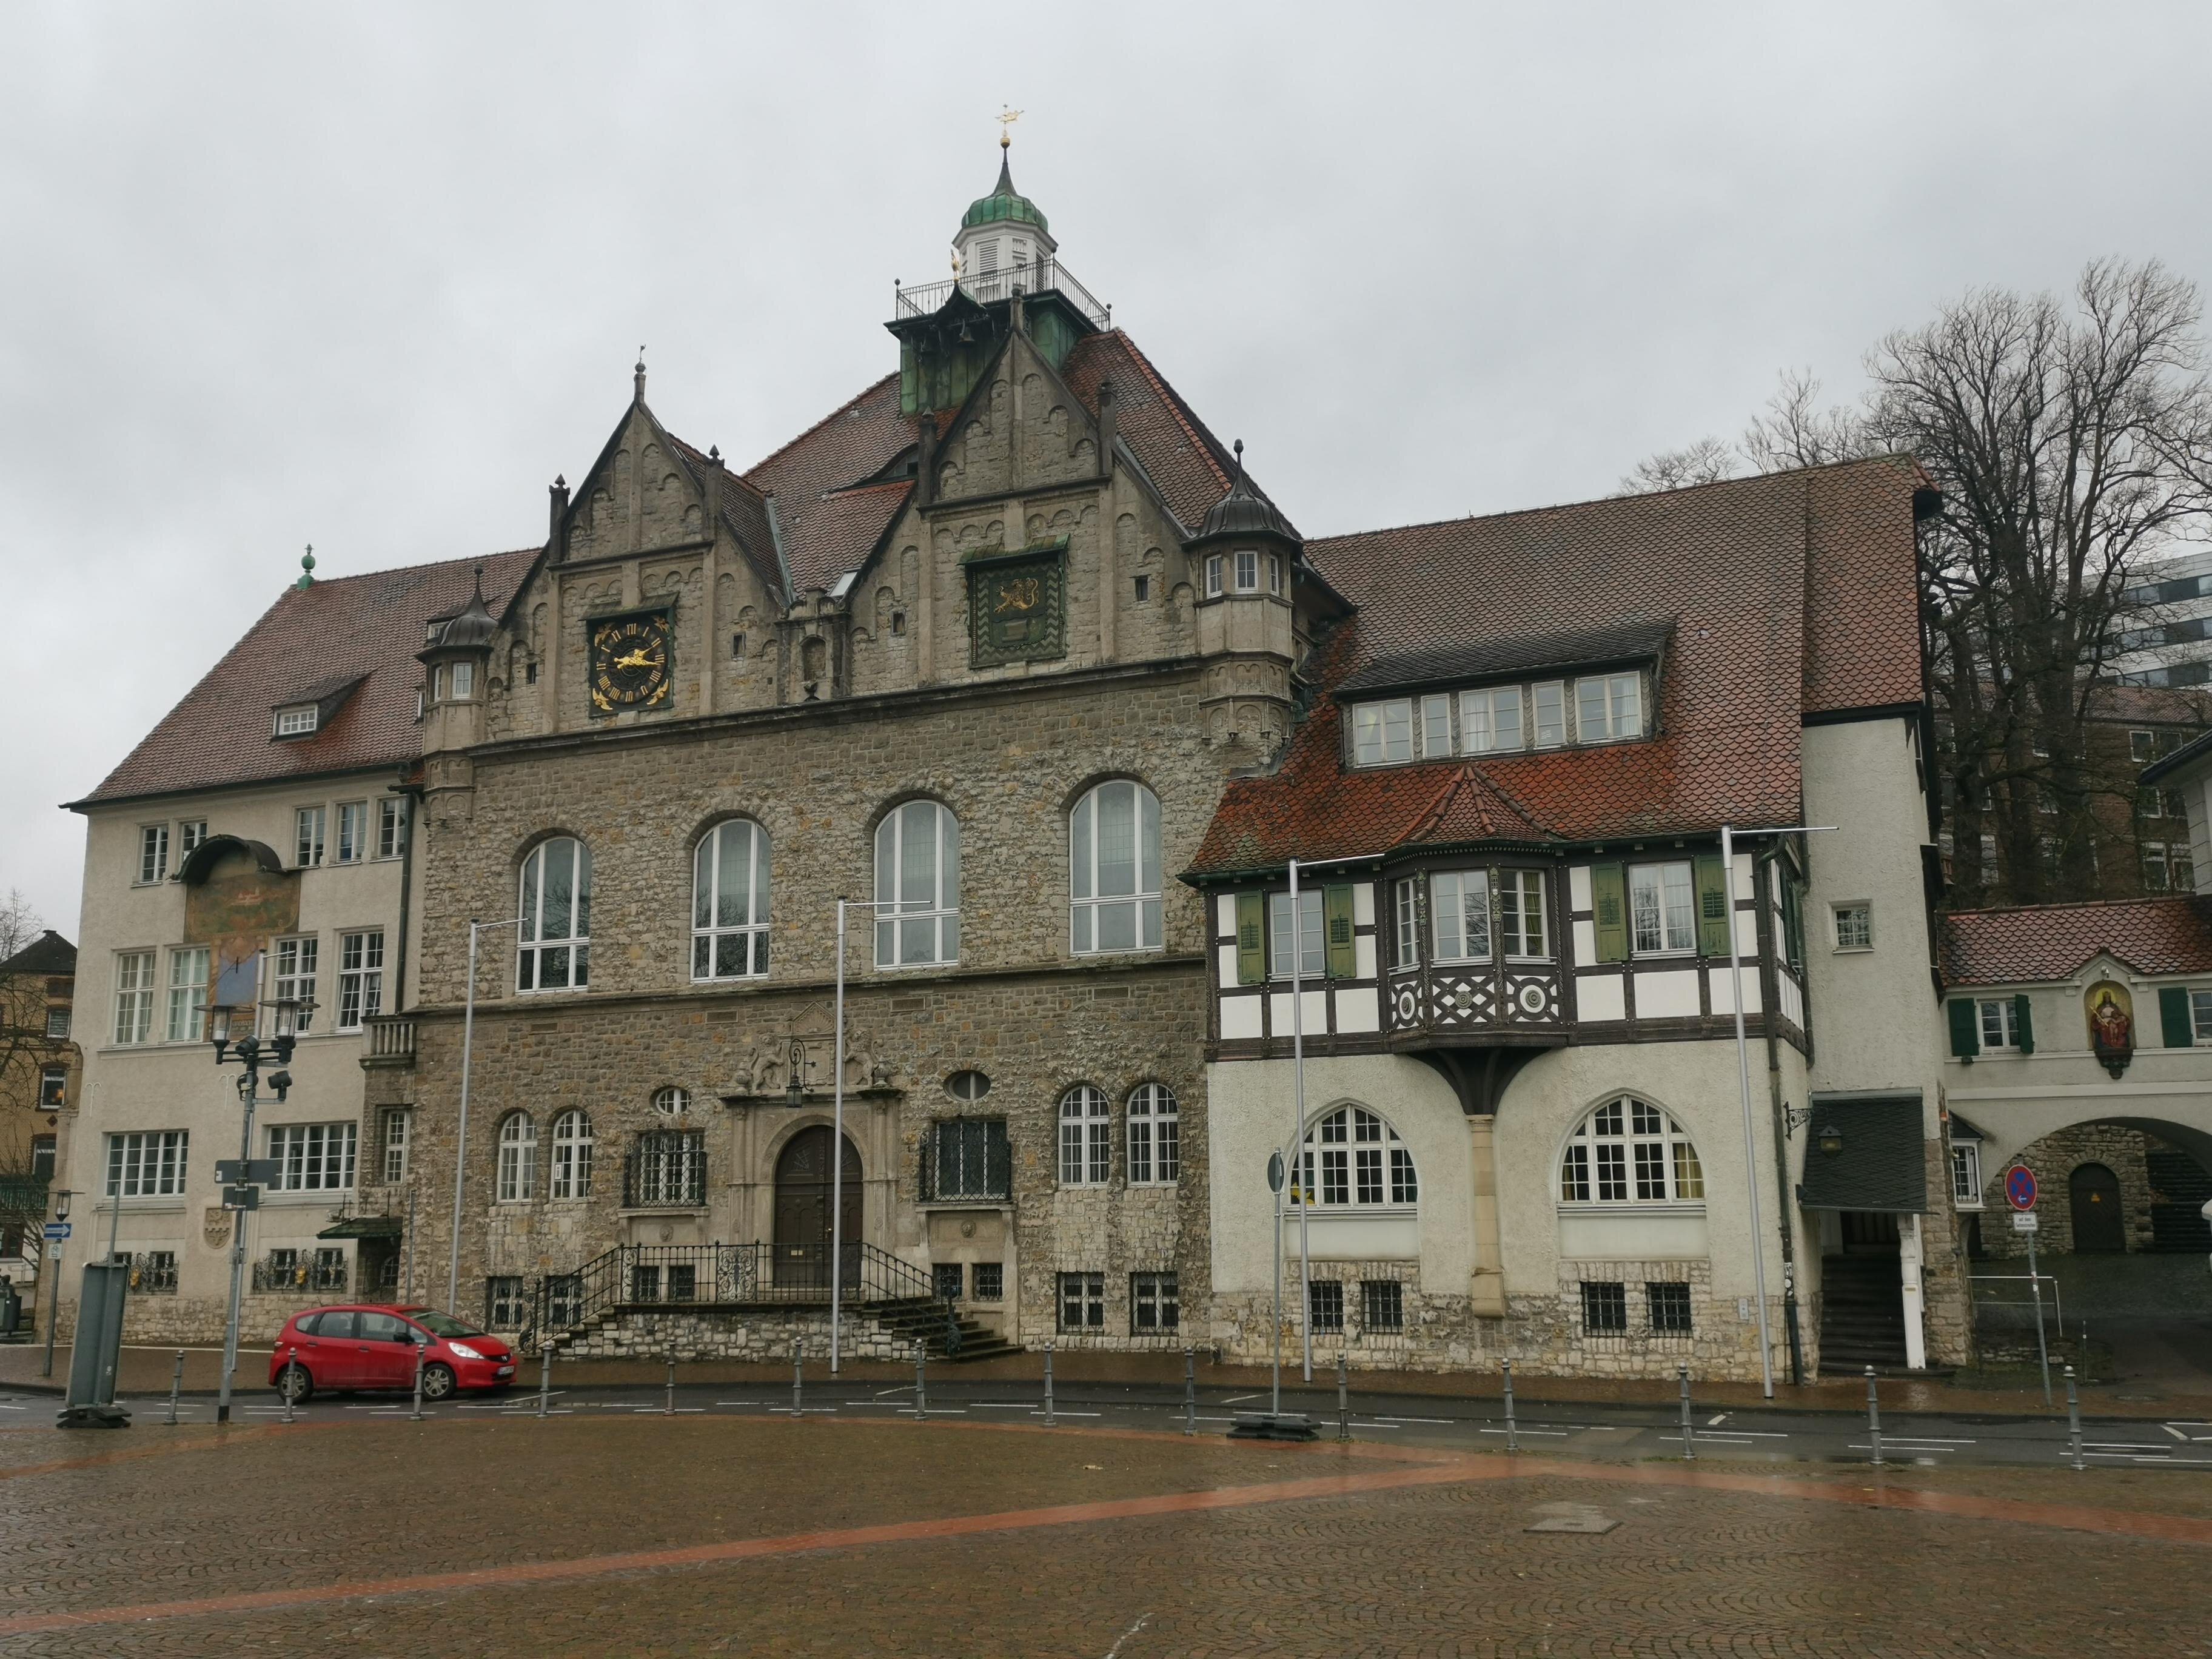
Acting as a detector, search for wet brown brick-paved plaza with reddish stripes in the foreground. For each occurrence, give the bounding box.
[0,1413,2212,1659]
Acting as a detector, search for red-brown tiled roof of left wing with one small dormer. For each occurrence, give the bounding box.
[73,546,540,805]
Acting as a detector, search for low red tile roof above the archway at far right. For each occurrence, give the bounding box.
[1938,894,2212,984]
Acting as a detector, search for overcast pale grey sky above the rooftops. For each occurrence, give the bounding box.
[0,0,2212,936]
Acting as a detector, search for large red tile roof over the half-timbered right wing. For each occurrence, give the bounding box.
[1192,460,1922,874]
